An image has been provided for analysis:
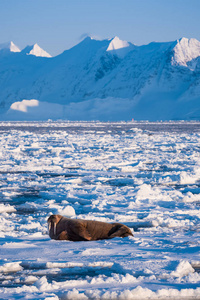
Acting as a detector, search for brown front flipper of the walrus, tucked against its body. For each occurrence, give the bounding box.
[68,222,92,241]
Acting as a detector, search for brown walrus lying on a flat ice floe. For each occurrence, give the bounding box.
[47,215,133,242]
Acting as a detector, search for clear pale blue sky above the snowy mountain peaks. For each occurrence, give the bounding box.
[0,0,200,56]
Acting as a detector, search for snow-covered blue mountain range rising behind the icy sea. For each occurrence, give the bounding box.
[0,37,200,120]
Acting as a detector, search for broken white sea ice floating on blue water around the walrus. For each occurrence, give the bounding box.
[0,121,200,300]
